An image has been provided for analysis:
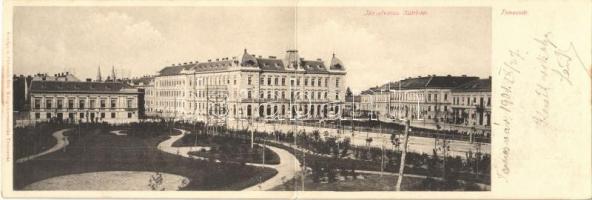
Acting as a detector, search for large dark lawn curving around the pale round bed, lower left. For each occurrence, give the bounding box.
[14,127,277,190]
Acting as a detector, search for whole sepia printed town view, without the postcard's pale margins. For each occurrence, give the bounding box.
[8,6,492,191]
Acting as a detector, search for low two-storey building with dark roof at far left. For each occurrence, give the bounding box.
[30,79,139,123]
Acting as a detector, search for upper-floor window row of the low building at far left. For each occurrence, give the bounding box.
[33,98,133,109]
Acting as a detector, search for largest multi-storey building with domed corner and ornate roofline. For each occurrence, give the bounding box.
[146,49,346,120]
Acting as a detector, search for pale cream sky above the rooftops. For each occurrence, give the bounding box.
[13,6,491,93]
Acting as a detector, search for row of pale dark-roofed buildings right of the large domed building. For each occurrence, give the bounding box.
[360,75,491,134]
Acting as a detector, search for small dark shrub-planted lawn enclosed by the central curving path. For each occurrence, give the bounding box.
[173,133,280,164]
